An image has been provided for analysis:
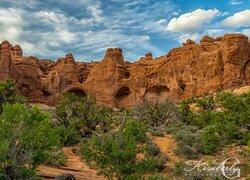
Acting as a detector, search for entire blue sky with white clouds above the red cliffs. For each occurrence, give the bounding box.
[0,0,250,61]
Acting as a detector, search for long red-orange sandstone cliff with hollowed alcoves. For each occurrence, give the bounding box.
[0,34,250,107]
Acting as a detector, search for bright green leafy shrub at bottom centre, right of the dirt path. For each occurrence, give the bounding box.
[81,120,164,179]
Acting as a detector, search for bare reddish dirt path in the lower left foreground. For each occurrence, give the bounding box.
[37,147,106,180]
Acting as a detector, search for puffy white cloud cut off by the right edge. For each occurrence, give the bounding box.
[222,9,250,28]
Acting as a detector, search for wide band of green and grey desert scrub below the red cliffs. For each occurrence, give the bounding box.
[0,80,250,179]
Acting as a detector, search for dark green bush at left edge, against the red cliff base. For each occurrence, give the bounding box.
[0,79,25,114]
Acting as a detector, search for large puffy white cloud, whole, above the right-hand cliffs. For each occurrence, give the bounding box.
[166,9,221,33]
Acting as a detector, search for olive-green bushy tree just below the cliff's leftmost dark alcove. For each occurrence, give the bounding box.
[54,93,98,145]
